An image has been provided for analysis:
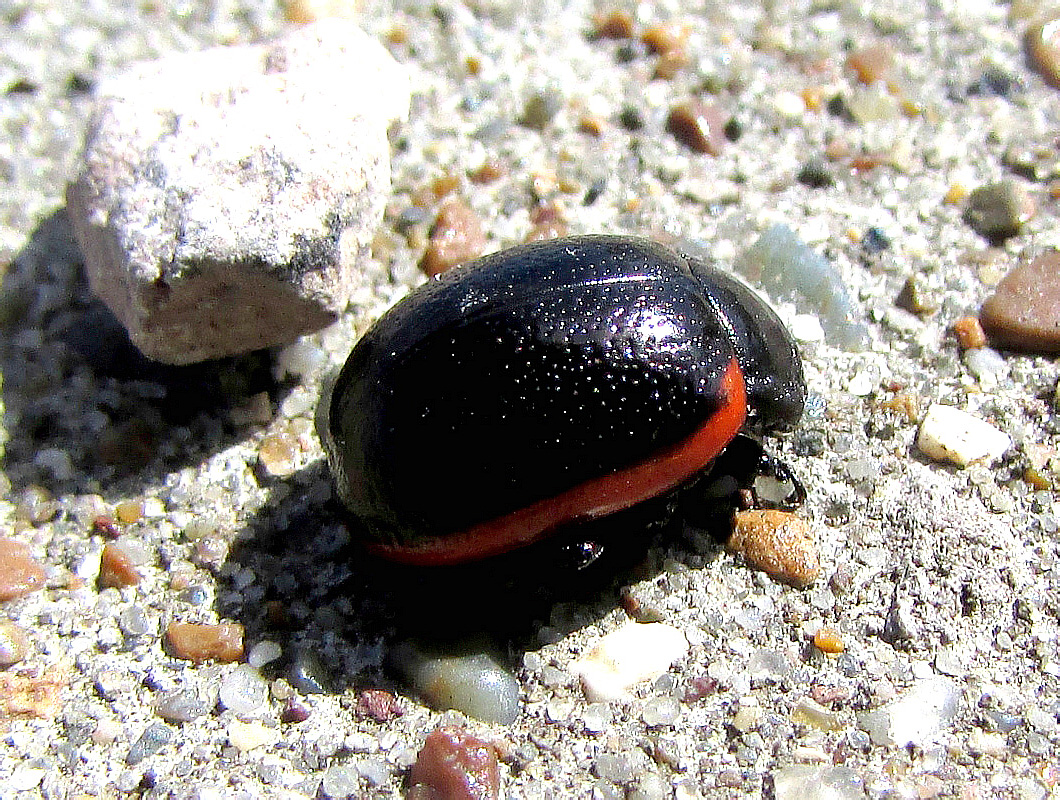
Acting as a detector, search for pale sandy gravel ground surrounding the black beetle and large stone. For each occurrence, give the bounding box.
[0,0,1060,800]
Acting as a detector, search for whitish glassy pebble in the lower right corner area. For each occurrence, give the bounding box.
[858,677,960,747]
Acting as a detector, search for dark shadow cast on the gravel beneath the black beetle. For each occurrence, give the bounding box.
[217,460,720,692]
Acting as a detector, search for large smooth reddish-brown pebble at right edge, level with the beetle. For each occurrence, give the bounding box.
[979,251,1060,353]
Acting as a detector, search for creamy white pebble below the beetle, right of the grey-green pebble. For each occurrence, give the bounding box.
[570,622,688,703]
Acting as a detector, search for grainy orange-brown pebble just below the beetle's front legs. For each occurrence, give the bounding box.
[727,509,820,589]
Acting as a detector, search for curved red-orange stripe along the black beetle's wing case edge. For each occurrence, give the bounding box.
[366,358,747,566]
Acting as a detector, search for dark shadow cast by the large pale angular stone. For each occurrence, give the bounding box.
[0,208,290,499]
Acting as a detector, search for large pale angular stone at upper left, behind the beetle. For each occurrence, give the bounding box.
[67,19,409,363]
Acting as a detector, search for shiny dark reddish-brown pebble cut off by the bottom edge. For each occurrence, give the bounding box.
[407,725,500,800]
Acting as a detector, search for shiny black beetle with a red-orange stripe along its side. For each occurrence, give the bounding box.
[322,234,806,566]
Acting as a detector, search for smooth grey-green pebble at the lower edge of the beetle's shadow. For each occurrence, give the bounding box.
[390,642,519,725]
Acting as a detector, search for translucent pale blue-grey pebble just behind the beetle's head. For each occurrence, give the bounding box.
[736,225,869,353]
